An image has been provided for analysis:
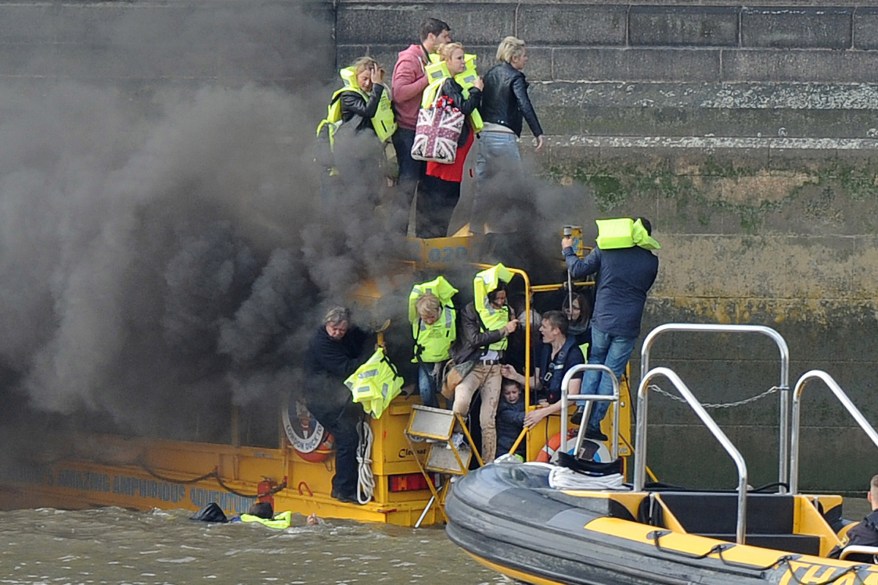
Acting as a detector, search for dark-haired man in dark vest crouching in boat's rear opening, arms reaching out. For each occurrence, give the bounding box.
[500,311,585,428]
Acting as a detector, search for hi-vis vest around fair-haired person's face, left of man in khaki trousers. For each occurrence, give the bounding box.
[409,276,458,363]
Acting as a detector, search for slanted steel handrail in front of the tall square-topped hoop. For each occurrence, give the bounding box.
[634,367,747,544]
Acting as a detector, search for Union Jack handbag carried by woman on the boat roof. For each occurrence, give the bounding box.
[412,96,466,164]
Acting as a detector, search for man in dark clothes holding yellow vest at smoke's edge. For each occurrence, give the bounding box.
[304,307,373,503]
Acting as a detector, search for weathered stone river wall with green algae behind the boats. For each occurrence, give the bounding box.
[0,0,878,490]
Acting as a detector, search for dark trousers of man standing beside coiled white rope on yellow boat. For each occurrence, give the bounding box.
[308,404,363,497]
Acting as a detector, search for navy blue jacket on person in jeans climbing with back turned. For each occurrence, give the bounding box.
[564,246,658,337]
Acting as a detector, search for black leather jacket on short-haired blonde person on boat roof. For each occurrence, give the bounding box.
[479,63,543,137]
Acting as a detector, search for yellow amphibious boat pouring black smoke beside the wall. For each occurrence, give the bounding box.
[0,237,608,526]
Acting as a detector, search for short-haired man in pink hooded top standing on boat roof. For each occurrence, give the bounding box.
[391,18,451,204]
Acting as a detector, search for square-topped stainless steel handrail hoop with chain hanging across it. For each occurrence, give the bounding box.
[636,323,790,490]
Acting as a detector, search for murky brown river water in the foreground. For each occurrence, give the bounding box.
[0,508,508,585]
